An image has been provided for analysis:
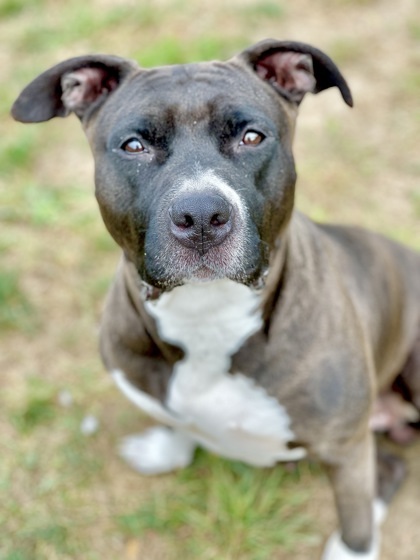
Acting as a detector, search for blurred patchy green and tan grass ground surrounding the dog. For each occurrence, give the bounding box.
[0,0,420,560]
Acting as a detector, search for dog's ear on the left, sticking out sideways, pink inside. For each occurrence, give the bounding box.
[12,55,138,123]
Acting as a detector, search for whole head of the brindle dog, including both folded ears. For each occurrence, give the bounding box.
[12,40,352,289]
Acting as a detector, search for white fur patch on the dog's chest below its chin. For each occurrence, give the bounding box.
[146,280,303,465]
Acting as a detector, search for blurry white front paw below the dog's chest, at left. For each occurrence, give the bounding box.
[119,426,195,475]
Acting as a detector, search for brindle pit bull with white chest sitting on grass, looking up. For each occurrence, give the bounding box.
[12,40,420,560]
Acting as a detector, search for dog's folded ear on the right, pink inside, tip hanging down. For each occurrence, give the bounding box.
[239,39,353,107]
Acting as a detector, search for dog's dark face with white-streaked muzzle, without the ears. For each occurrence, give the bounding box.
[91,64,295,288]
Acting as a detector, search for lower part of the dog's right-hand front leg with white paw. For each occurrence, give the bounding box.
[322,433,383,560]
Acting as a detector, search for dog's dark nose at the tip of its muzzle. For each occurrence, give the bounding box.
[169,193,233,255]
